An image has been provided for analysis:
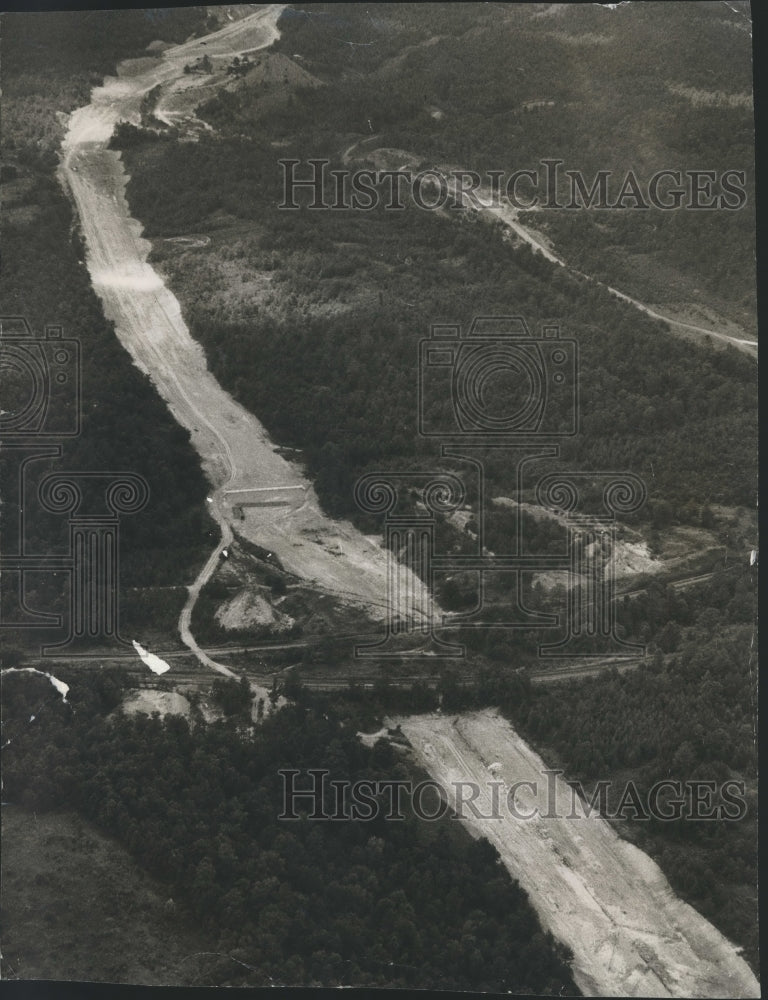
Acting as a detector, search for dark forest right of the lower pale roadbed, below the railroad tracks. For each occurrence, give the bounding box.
[472,609,759,969]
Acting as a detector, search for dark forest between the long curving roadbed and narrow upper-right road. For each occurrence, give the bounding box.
[116,126,756,518]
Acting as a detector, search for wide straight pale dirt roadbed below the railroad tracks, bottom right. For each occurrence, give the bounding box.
[400,710,760,997]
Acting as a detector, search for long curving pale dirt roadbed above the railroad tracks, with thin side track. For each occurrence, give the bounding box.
[60,5,432,688]
